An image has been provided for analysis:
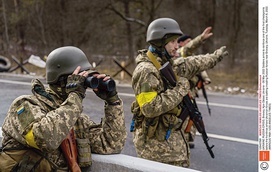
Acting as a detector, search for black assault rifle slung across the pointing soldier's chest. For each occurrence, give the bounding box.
[160,62,215,158]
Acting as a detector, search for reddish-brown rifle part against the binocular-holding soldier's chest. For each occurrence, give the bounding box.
[61,129,81,172]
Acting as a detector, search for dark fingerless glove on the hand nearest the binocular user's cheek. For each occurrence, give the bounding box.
[66,74,86,98]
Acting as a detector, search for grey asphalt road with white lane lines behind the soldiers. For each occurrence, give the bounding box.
[0,74,258,172]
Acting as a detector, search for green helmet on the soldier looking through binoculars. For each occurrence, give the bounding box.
[46,46,92,84]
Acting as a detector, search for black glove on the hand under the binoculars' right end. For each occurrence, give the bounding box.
[94,78,119,104]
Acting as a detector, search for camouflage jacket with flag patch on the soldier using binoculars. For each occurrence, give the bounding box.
[0,80,126,171]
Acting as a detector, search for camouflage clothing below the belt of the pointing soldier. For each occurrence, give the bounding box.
[133,128,190,167]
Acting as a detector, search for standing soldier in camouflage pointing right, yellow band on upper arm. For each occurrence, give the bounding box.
[131,18,228,167]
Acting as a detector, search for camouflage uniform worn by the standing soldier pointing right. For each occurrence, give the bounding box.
[131,50,224,167]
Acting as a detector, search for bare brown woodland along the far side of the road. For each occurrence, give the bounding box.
[0,0,258,95]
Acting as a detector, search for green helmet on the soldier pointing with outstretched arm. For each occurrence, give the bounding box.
[147,18,183,43]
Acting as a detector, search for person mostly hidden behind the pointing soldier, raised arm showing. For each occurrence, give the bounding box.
[177,27,213,148]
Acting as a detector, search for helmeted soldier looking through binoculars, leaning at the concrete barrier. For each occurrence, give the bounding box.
[0,46,126,171]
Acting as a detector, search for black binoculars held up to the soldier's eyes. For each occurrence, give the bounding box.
[84,76,116,91]
